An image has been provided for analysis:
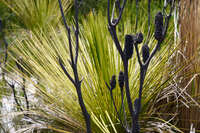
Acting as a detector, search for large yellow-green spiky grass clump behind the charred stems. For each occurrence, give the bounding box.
[6,14,181,133]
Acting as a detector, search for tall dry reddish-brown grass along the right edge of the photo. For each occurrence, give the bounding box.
[179,0,200,132]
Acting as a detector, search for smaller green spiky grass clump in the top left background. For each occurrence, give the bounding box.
[2,0,73,30]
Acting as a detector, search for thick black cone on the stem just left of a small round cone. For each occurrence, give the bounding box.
[124,35,134,60]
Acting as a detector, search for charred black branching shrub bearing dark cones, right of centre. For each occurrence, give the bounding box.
[107,0,175,133]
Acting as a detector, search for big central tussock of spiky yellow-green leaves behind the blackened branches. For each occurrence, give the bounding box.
[3,1,184,133]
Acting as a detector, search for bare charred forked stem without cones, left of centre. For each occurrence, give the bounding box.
[58,0,92,133]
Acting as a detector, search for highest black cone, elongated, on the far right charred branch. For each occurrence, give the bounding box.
[154,12,163,41]
